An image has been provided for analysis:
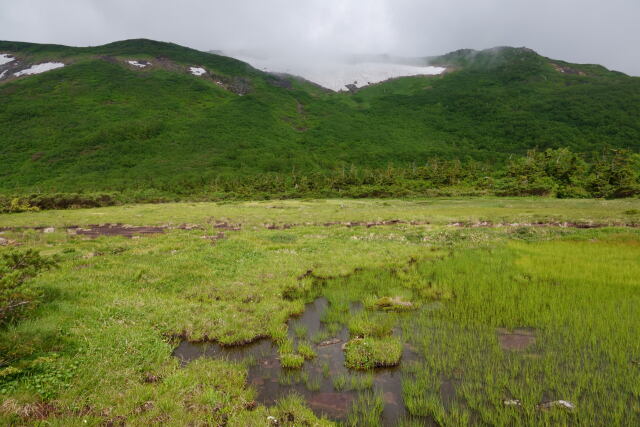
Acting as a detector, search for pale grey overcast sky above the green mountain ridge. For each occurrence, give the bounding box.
[0,0,640,75]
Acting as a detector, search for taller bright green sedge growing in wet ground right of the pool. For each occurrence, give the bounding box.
[403,237,640,425]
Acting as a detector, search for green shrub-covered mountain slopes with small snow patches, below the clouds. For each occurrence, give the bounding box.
[0,40,640,194]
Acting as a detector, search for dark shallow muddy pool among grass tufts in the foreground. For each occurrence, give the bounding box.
[174,298,418,426]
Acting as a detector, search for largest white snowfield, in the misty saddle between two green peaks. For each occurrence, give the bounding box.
[230,56,446,91]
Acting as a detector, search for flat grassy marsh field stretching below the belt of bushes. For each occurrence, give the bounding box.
[0,198,640,426]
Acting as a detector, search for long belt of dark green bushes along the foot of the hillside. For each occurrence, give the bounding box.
[0,148,640,212]
